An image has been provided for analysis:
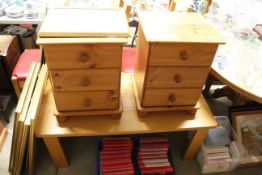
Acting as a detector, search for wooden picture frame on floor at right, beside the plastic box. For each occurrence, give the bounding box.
[229,106,262,166]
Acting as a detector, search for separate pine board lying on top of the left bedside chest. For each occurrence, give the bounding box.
[38,9,129,38]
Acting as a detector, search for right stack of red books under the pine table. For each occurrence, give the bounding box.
[137,137,174,175]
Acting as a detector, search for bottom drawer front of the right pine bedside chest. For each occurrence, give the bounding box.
[142,88,201,106]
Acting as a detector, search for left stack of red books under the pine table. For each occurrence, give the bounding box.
[99,137,135,175]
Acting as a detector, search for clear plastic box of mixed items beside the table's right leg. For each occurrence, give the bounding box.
[197,116,248,173]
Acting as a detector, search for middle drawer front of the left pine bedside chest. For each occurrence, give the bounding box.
[50,69,120,91]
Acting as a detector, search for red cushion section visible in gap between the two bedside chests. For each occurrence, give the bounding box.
[122,47,136,73]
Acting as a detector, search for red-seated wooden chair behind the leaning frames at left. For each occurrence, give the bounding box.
[11,49,41,97]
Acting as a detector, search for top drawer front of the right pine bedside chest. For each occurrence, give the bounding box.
[149,43,218,66]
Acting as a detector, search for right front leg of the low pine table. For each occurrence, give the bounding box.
[184,128,208,160]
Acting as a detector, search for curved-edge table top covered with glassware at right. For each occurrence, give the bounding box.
[206,0,262,103]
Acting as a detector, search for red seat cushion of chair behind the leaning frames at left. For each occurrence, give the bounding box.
[13,49,40,80]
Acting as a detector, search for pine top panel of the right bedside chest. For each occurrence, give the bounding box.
[139,11,225,44]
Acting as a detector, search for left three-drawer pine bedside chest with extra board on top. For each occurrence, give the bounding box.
[37,9,129,121]
